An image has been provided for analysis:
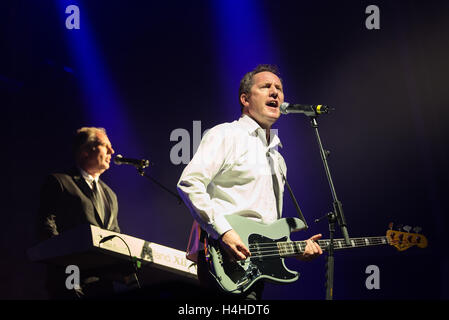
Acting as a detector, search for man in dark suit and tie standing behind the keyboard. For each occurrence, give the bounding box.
[39,127,120,299]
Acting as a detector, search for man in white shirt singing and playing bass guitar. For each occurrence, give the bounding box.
[178,65,322,300]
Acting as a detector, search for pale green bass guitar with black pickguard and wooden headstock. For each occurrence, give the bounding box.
[206,215,427,294]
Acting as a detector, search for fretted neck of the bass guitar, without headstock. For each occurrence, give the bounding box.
[277,236,389,257]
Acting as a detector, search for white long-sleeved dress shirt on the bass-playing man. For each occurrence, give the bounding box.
[178,115,287,260]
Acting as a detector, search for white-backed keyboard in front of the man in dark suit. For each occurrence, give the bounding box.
[27,225,198,284]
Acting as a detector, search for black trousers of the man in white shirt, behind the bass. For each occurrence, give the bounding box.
[197,251,264,301]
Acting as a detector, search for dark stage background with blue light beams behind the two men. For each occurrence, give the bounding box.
[0,0,449,300]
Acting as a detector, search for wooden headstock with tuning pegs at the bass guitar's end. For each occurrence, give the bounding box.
[386,223,427,251]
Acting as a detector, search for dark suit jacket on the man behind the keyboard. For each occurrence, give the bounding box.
[39,168,120,239]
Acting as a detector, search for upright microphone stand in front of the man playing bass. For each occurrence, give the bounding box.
[310,115,350,300]
